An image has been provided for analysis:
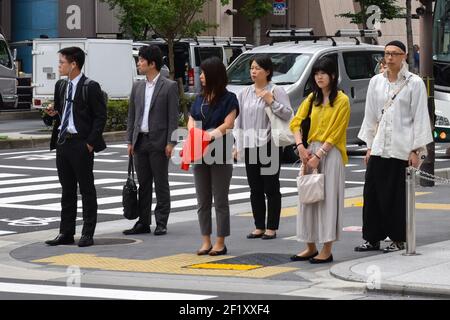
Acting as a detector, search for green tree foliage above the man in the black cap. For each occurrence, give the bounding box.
[336,0,404,42]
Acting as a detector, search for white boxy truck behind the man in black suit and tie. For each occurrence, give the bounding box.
[32,38,137,108]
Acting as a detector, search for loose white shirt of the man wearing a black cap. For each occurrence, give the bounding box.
[358,64,433,160]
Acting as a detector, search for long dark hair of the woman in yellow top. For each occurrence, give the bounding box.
[309,57,339,106]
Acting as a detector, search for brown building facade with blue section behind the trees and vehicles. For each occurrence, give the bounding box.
[0,0,419,73]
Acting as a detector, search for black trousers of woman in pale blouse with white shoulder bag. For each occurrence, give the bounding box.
[244,143,282,230]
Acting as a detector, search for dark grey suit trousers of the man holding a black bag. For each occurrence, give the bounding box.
[134,134,170,228]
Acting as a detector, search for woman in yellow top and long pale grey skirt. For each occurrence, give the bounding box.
[290,57,350,264]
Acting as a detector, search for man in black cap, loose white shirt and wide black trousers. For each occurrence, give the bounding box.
[355,41,433,252]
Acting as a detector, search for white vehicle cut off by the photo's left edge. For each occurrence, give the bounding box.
[0,34,17,110]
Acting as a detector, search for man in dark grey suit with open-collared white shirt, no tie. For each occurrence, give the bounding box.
[123,45,179,235]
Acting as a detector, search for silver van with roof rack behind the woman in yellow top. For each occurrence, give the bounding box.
[227,40,384,143]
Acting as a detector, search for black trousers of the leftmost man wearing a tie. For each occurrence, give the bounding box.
[56,138,97,236]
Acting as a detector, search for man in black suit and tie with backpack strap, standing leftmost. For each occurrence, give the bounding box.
[44,47,106,247]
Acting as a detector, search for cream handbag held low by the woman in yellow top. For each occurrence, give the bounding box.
[297,164,325,204]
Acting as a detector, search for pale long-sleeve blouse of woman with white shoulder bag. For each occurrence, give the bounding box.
[233,82,294,151]
